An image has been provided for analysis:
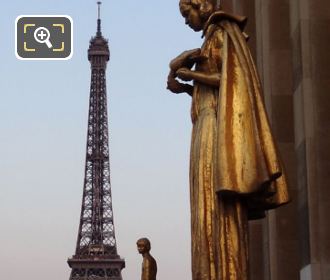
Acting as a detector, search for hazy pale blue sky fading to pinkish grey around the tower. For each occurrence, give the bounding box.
[0,0,201,280]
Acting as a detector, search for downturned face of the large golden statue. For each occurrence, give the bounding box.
[179,0,203,31]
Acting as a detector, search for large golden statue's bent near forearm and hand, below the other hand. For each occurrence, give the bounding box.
[176,67,221,87]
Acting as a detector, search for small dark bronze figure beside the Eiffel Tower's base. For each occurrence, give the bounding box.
[136,238,157,280]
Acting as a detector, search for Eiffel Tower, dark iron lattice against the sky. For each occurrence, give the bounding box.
[68,2,125,280]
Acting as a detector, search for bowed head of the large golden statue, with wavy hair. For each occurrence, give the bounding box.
[179,0,217,31]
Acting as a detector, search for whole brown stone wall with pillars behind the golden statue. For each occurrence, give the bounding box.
[222,0,330,280]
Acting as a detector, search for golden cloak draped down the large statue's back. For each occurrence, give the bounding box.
[206,11,289,219]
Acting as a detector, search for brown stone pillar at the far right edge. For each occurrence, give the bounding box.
[291,0,330,280]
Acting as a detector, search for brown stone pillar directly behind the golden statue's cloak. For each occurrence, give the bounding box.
[251,0,299,280]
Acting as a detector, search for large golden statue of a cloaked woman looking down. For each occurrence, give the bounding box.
[168,0,289,280]
